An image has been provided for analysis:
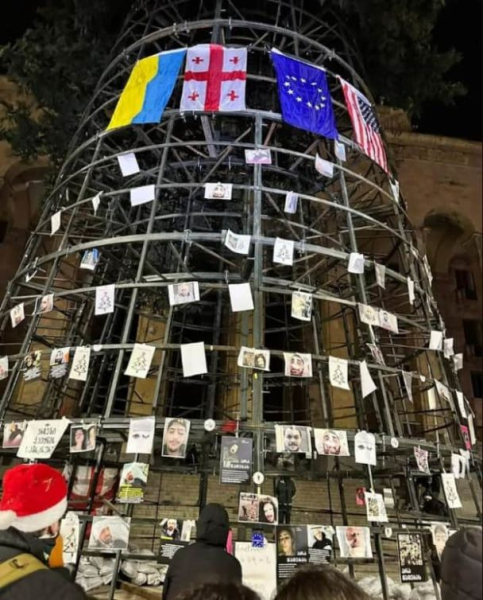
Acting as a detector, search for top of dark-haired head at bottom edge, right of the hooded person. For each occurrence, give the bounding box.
[275,566,369,600]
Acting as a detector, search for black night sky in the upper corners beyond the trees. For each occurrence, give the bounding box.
[0,0,483,140]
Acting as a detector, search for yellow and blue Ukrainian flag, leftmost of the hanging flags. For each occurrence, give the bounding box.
[107,50,186,131]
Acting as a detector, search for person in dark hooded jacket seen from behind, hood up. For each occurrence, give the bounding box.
[163,504,242,600]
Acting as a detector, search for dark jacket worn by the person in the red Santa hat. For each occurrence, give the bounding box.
[0,527,86,600]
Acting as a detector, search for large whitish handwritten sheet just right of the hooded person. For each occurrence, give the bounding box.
[235,542,277,600]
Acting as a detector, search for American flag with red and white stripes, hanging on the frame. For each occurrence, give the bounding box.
[340,78,389,173]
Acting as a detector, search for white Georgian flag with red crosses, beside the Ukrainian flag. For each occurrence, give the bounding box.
[181,44,247,112]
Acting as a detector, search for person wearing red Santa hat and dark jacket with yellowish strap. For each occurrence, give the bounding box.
[0,463,86,600]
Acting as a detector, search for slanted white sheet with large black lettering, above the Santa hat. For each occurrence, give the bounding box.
[17,419,70,459]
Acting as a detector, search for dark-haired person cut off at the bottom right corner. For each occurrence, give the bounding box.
[441,529,483,600]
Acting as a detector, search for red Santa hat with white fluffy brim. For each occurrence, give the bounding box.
[0,463,67,533]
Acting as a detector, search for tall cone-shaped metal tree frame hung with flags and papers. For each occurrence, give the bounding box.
[0,0,481,598]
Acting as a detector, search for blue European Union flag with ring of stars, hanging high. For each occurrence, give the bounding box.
[271,49,339,140]
